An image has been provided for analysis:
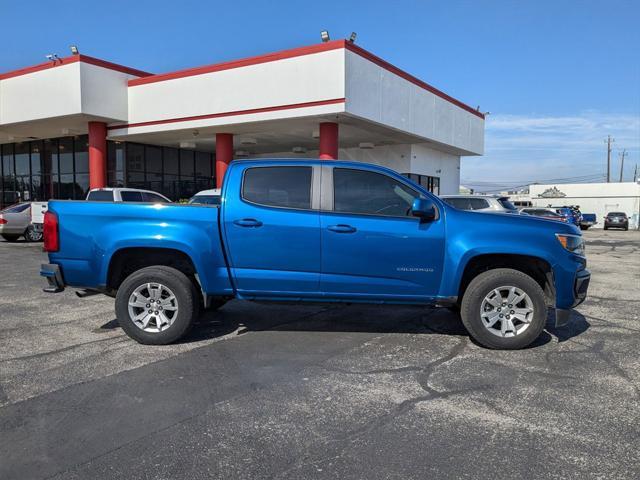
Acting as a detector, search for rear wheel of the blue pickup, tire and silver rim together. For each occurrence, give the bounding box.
[116,266,198,345]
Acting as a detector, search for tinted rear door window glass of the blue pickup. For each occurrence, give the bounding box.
[242,166,312,210]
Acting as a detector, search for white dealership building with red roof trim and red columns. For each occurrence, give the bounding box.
[0,40,484,206]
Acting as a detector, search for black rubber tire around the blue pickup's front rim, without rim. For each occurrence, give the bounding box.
[460,268,547,350]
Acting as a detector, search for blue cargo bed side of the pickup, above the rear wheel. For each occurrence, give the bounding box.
[49,200,232,295]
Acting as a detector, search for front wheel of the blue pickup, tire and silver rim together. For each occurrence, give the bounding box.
[460,268,547,350]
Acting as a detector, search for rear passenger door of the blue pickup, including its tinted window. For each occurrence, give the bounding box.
[221,162,320,298]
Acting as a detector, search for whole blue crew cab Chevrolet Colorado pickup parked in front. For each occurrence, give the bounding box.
[41,159,590,349]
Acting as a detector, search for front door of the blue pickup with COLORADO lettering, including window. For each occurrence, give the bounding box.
[320,166,444,301]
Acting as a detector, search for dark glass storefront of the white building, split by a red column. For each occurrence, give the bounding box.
[0,135,215,208]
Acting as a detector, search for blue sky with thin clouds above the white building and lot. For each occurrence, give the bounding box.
[0,0,640,189]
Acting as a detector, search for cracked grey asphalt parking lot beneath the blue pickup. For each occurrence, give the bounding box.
[0,230,640,479]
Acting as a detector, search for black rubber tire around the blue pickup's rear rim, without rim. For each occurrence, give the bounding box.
[116,266,198,345]
